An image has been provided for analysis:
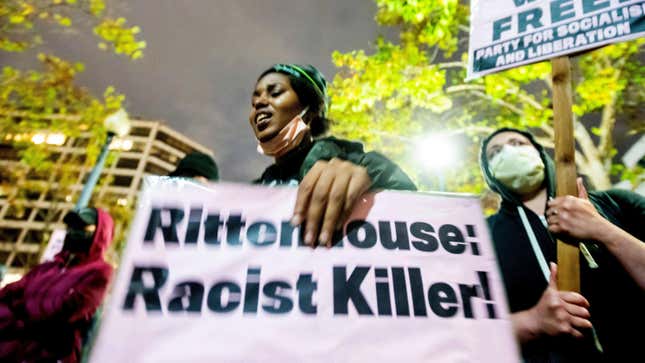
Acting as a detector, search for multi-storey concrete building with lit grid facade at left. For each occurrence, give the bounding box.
[0,120,213,274]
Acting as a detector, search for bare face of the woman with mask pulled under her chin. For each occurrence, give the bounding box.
[249,73,303,142]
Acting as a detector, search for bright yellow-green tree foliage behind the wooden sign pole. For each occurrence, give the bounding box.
[330,0,645,190]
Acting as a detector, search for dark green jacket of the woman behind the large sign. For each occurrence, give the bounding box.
[255,137,417,190]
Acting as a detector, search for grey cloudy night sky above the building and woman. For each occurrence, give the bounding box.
[0,0,379,181]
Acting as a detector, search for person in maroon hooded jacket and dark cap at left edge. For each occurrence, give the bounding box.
[0,208,114,362]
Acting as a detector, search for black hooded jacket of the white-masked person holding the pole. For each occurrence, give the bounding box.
[480,129,645,362]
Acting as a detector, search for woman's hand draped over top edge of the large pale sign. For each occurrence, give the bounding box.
[291,158,372,247]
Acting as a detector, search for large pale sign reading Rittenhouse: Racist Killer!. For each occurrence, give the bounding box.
[91,180,519,363]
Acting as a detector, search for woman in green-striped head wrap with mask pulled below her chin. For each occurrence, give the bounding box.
[249,64,416,246]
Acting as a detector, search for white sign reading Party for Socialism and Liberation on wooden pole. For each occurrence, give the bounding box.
[467,0,645,79]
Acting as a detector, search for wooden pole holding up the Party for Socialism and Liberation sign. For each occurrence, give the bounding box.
[551,56,580,292]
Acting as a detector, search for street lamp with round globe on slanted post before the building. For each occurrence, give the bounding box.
[74,109,130,210]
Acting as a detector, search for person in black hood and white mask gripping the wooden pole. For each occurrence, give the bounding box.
[480,128,645,362]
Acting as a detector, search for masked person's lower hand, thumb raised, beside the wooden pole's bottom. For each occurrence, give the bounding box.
[512,263,591,343]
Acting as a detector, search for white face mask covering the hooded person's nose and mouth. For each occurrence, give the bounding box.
[489,145,544,194]
